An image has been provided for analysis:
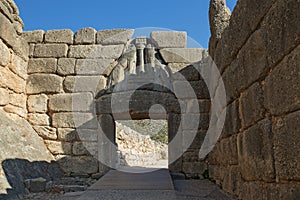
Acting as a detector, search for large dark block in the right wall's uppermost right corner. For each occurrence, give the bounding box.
[262,0,300,67]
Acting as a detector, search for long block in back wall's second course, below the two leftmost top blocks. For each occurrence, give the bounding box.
[33,44,68,58]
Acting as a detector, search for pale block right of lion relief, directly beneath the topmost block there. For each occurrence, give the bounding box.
[159,48,203,63]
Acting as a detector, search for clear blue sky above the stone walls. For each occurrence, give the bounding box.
[15,0,237,48]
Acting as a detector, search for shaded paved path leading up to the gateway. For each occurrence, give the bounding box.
[61,169,231,200]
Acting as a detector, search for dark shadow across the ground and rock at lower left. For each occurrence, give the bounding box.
[0,120,101,199]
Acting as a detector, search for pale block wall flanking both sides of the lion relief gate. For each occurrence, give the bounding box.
[22,28,210,177]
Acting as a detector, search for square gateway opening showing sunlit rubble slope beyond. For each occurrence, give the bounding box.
[116,119,168,169]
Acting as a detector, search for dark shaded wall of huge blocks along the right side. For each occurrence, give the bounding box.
[208,0,300,199]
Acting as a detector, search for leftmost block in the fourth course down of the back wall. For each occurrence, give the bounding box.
[26,74,63,94]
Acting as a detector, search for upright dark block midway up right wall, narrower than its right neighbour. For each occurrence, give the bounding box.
[240,83,265,127]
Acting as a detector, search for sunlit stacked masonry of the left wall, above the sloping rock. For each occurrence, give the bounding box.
[0,0,29,118]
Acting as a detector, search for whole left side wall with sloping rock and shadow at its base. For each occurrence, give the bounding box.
[0,0,56,199]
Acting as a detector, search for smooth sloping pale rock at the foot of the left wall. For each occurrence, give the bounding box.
[0,111,53,194]
